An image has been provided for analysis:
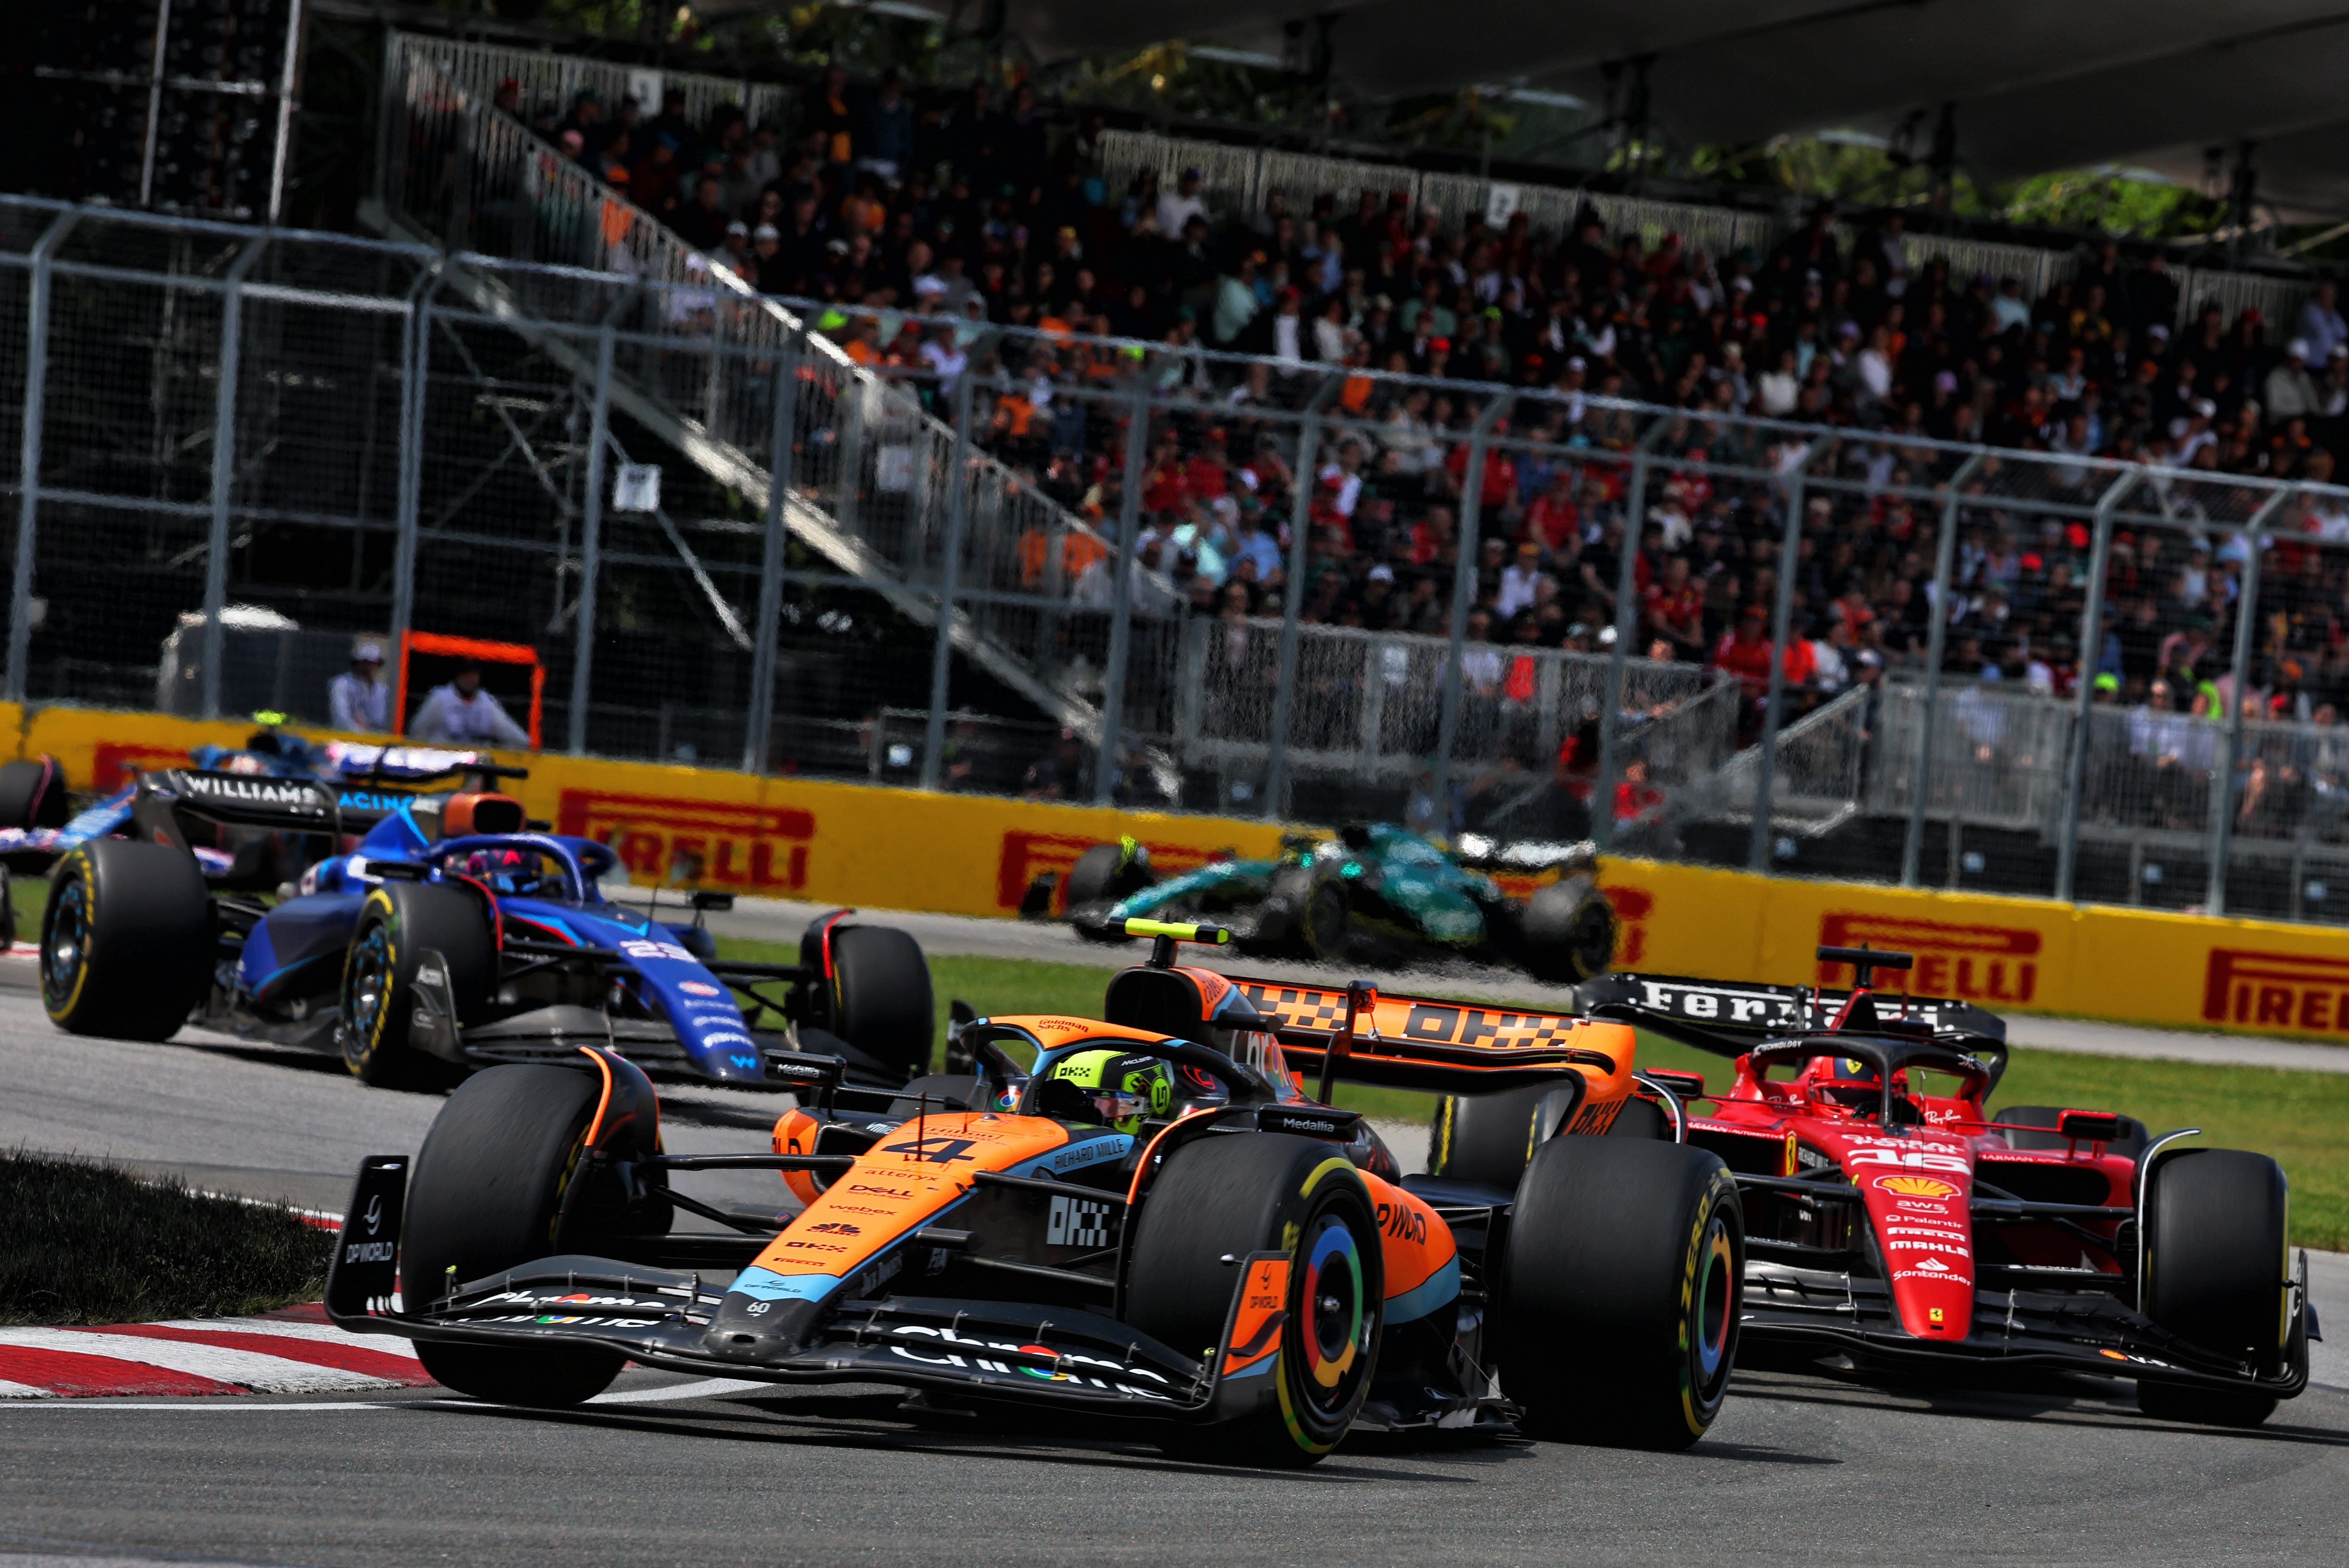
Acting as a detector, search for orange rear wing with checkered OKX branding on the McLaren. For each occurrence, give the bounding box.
[1224,974,1633,1094]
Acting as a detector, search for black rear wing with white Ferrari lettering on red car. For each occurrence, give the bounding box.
[1574,974,2006,1063]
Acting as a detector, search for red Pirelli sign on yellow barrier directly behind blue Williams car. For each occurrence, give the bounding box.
[555,789,815,894]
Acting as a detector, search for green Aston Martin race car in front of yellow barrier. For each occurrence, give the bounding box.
[1022,824,1616,986]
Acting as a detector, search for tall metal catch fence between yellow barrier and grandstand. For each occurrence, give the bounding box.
[14,180,2349,920]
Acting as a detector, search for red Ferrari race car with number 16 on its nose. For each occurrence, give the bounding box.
[1550,948,2321,1425]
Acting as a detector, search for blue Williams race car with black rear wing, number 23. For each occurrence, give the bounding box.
[40,751,932,1089]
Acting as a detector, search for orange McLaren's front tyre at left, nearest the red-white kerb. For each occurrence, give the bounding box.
[399,1063,622,1406]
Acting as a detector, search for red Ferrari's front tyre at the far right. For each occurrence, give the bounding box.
[2137,1148,2290,1427]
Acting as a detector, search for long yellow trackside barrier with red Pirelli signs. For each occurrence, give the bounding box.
[14,704,2349,1045]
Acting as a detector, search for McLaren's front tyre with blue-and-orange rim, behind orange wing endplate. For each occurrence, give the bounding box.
[1125,1134,1386,1469]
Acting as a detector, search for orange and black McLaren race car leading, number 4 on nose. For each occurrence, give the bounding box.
[327,920,1745,1465]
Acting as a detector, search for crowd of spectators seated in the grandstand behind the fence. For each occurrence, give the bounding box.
[519,70,2349,770]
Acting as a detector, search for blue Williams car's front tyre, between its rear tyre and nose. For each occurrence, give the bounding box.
[336,880,498,1089]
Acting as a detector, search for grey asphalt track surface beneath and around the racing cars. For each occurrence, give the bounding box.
[0,929,2349,1568]
